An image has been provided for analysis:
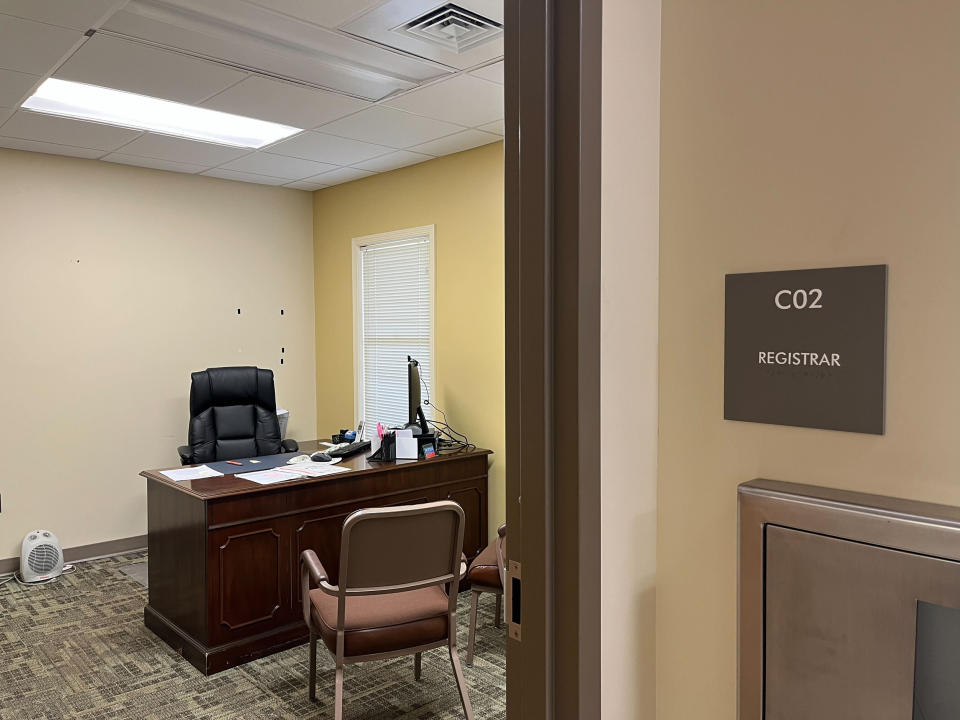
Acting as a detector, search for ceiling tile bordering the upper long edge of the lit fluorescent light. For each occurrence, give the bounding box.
[54,34,247,105]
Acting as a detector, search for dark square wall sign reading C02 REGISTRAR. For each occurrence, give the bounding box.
[723,265,887,435]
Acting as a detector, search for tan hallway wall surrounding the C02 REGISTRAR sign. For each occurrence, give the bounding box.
[657,0,960,720]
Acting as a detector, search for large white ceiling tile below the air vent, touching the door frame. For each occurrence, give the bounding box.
[385,75,503,127]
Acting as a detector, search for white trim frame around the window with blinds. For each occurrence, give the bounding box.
[352,225,437,427]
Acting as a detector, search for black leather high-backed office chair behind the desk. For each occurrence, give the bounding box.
[177,367,299,465]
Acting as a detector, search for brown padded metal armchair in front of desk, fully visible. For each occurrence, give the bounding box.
[300,500,473,720]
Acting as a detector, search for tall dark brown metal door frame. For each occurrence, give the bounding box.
[504,0,602,720]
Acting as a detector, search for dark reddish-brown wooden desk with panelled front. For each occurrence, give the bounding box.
[140,442,491,675]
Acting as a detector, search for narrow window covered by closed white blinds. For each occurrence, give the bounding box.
[353,225,434,439]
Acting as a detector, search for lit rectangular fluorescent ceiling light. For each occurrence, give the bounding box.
[23,78,301,148]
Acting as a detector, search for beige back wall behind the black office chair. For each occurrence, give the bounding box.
[0,150,316,558]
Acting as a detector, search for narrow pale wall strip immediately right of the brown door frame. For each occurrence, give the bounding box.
[600,0,660,720]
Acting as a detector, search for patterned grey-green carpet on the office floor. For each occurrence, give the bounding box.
[0,553,506,720]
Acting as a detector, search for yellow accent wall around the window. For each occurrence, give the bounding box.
[313,143,506,533]
